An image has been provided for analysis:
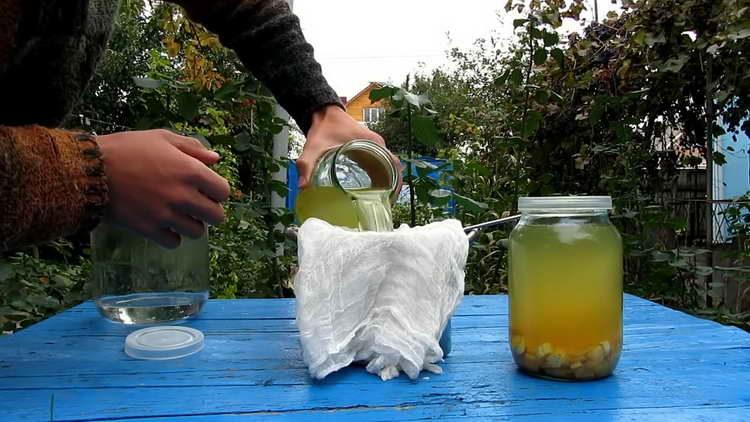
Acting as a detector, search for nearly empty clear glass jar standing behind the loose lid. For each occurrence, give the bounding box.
[90,223,209,324]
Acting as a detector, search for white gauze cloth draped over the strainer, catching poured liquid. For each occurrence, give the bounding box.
[294,219,469,380]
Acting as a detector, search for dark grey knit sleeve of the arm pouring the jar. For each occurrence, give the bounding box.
[171,0,343,133]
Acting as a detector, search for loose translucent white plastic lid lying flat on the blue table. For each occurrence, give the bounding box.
[125,326,204,360]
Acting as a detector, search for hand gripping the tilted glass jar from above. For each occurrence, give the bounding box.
[297,105,401,188]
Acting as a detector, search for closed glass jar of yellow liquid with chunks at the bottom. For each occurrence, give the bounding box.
[509,196,623,380]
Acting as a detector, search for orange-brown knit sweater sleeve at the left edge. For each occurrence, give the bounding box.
[0,126,108,251]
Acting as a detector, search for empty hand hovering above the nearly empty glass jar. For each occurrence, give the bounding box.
[96,130,229,248]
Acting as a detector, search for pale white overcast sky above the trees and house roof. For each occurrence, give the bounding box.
[294,0,616,98]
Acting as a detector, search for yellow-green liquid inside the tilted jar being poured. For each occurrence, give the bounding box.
[295,186,393,232]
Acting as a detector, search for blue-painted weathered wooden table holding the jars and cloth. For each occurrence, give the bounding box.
[0,296,750,422]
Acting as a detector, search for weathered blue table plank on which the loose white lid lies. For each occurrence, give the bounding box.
[0,324,750,380]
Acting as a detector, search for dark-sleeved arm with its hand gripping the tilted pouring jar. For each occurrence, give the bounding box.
[171,0,401,187]
